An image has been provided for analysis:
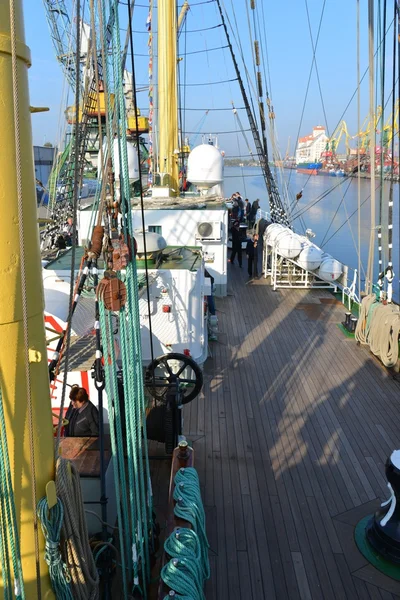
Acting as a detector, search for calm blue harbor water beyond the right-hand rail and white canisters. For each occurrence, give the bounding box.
[225,167,400,301]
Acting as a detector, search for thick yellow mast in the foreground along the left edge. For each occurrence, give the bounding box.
[0,0,54,600]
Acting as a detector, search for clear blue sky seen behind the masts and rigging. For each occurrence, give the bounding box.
[24,0,378,155]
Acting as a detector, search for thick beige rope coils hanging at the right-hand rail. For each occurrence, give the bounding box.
[355,294,400,367]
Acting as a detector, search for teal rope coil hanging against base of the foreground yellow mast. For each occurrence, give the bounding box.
[37,497,73,600]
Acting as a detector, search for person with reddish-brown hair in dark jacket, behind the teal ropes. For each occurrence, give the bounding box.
[65,385,99,437]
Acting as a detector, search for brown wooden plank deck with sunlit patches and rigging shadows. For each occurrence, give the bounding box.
[185,265,400,600]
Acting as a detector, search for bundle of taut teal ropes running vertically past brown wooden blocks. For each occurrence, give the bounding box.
[93,0,153,598]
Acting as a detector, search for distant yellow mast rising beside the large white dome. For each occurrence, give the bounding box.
[157,0,179,195]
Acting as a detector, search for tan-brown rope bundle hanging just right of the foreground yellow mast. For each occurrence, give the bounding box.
[56,458,100,600]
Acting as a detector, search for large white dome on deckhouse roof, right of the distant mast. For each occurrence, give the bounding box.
[187,144,224,189]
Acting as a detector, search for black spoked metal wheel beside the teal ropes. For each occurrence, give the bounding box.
[145,352,203,404]
